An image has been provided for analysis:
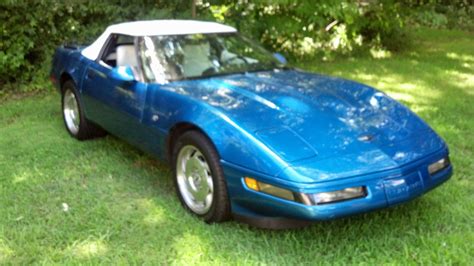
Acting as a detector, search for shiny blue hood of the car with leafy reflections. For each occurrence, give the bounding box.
[165,70,443,179]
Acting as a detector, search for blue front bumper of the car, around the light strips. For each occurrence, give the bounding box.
[222,150,453,227]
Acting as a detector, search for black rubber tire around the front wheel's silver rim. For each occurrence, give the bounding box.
[172,130,231,223]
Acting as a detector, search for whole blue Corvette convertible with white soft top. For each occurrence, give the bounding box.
[51,20,452,228]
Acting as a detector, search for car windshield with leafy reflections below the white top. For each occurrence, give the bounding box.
[139,33,283,83]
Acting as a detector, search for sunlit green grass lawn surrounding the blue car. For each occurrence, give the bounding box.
[0,30,474,264]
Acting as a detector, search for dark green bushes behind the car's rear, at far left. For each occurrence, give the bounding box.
[0,0,190,90]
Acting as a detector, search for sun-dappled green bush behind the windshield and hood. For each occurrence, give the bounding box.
[204,0,402,58]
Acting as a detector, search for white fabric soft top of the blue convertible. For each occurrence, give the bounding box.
[82,20,237,60]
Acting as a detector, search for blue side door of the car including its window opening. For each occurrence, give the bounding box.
[82,34,148,148]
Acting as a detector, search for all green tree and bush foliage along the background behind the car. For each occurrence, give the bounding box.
[0,0,472,91]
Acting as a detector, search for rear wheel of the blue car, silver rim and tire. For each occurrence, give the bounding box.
[61,80,106,140]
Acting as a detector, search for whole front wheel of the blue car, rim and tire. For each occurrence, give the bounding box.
[173,131,230,223]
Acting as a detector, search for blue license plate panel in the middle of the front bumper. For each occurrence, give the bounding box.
[383,172,423,205]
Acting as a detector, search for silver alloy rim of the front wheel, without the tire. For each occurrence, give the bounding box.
[176,145,214,215]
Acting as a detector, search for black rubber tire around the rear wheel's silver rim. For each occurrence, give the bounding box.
[61,80,107,140]
